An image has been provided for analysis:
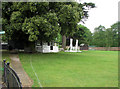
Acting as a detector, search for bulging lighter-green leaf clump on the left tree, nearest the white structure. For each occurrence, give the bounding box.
[22,13,60,41]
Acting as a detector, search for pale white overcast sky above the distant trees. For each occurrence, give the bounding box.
[80,0,120,32]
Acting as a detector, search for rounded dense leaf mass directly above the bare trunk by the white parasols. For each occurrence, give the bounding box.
[58,2,81,35]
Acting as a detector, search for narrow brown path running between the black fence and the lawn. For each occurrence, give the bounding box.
[10,54,33,87]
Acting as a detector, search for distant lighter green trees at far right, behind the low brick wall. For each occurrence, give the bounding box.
[92,22,120,47]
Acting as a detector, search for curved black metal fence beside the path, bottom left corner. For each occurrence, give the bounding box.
[2,60,22,89]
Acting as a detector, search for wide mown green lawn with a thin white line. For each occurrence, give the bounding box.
[19,51,118,87]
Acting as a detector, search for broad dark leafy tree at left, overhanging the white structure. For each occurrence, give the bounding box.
[2,2,60,49]
